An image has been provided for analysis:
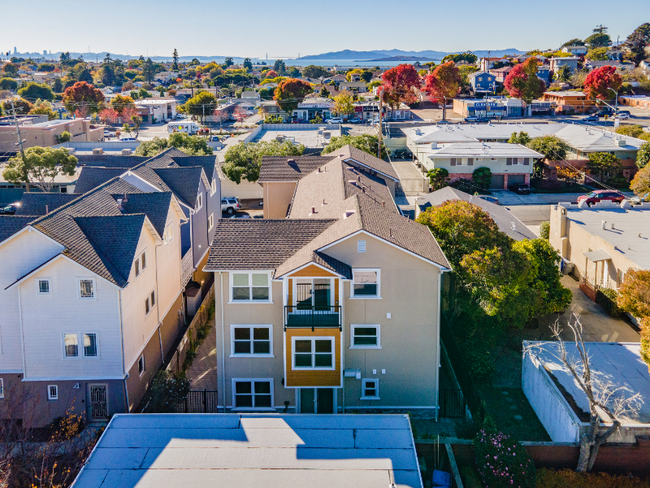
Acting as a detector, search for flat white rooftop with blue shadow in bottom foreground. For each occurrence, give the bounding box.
[73,414,423,488]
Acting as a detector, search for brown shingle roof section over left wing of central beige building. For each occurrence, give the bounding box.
[205,219,335,271]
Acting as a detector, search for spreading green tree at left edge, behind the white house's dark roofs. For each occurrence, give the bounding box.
[2,146,77,192]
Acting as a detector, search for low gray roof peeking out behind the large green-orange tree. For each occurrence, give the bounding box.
[417,186,537,241]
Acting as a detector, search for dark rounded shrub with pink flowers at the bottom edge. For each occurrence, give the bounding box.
[474,430,535,488]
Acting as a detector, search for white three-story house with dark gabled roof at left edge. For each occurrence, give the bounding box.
[0,179,186,427]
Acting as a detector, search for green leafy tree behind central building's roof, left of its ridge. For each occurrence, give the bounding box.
[222,140,305,184]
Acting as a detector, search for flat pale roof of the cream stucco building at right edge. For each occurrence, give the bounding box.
[560,201,650,269]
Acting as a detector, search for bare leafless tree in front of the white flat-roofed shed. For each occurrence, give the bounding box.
[527,314,643,472]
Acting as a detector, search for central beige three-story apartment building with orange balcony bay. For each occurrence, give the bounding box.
[206,148,450,414]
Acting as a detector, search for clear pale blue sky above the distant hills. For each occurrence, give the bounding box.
[0,0,650,58]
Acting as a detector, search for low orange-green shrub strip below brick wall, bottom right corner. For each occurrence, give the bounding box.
[536,469,650,488]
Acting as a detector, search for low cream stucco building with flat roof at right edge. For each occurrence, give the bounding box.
[550,202,650,289]
